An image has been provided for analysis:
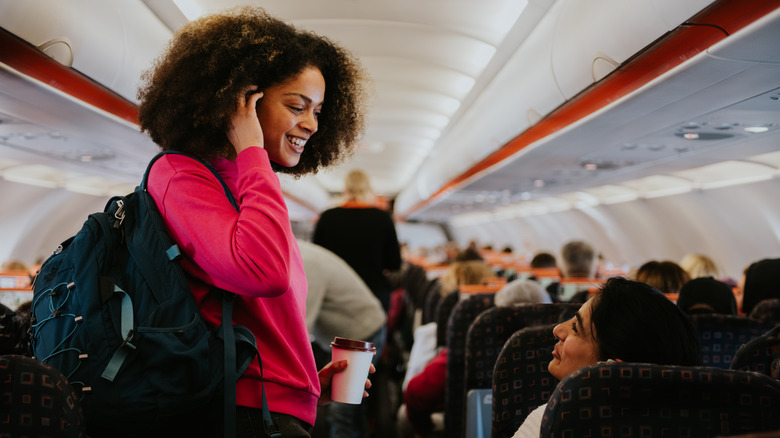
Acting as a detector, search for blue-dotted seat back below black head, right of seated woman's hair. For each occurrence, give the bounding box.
[689,313,774,369]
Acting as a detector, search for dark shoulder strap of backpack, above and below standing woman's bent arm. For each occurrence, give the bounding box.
[146,150,282,438]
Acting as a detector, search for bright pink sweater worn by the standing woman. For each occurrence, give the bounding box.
[149,147,320,425]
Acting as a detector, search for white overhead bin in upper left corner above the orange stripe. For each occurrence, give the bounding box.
[0,0,172,102]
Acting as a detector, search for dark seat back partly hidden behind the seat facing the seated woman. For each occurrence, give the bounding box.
[465,303,580,393]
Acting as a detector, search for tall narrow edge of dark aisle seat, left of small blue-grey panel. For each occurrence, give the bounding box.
[444,293,495,438]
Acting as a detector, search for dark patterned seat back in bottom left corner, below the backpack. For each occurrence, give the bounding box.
[0,355,86,438]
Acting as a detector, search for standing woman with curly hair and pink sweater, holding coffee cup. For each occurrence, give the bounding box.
[139,8,364,437]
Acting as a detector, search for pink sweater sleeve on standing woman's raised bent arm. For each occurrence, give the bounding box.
[149,147,298,296]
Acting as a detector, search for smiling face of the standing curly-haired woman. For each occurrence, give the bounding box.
[257,67,325,167]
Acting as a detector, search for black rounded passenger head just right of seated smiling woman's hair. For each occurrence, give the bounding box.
[677,277,737,315]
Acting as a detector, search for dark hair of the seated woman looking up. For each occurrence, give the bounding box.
[590,277,701,366]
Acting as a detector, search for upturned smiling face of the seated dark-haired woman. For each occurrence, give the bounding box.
[547,299,598,380]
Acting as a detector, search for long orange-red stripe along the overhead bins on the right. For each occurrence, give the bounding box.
[405,0,780,217]
